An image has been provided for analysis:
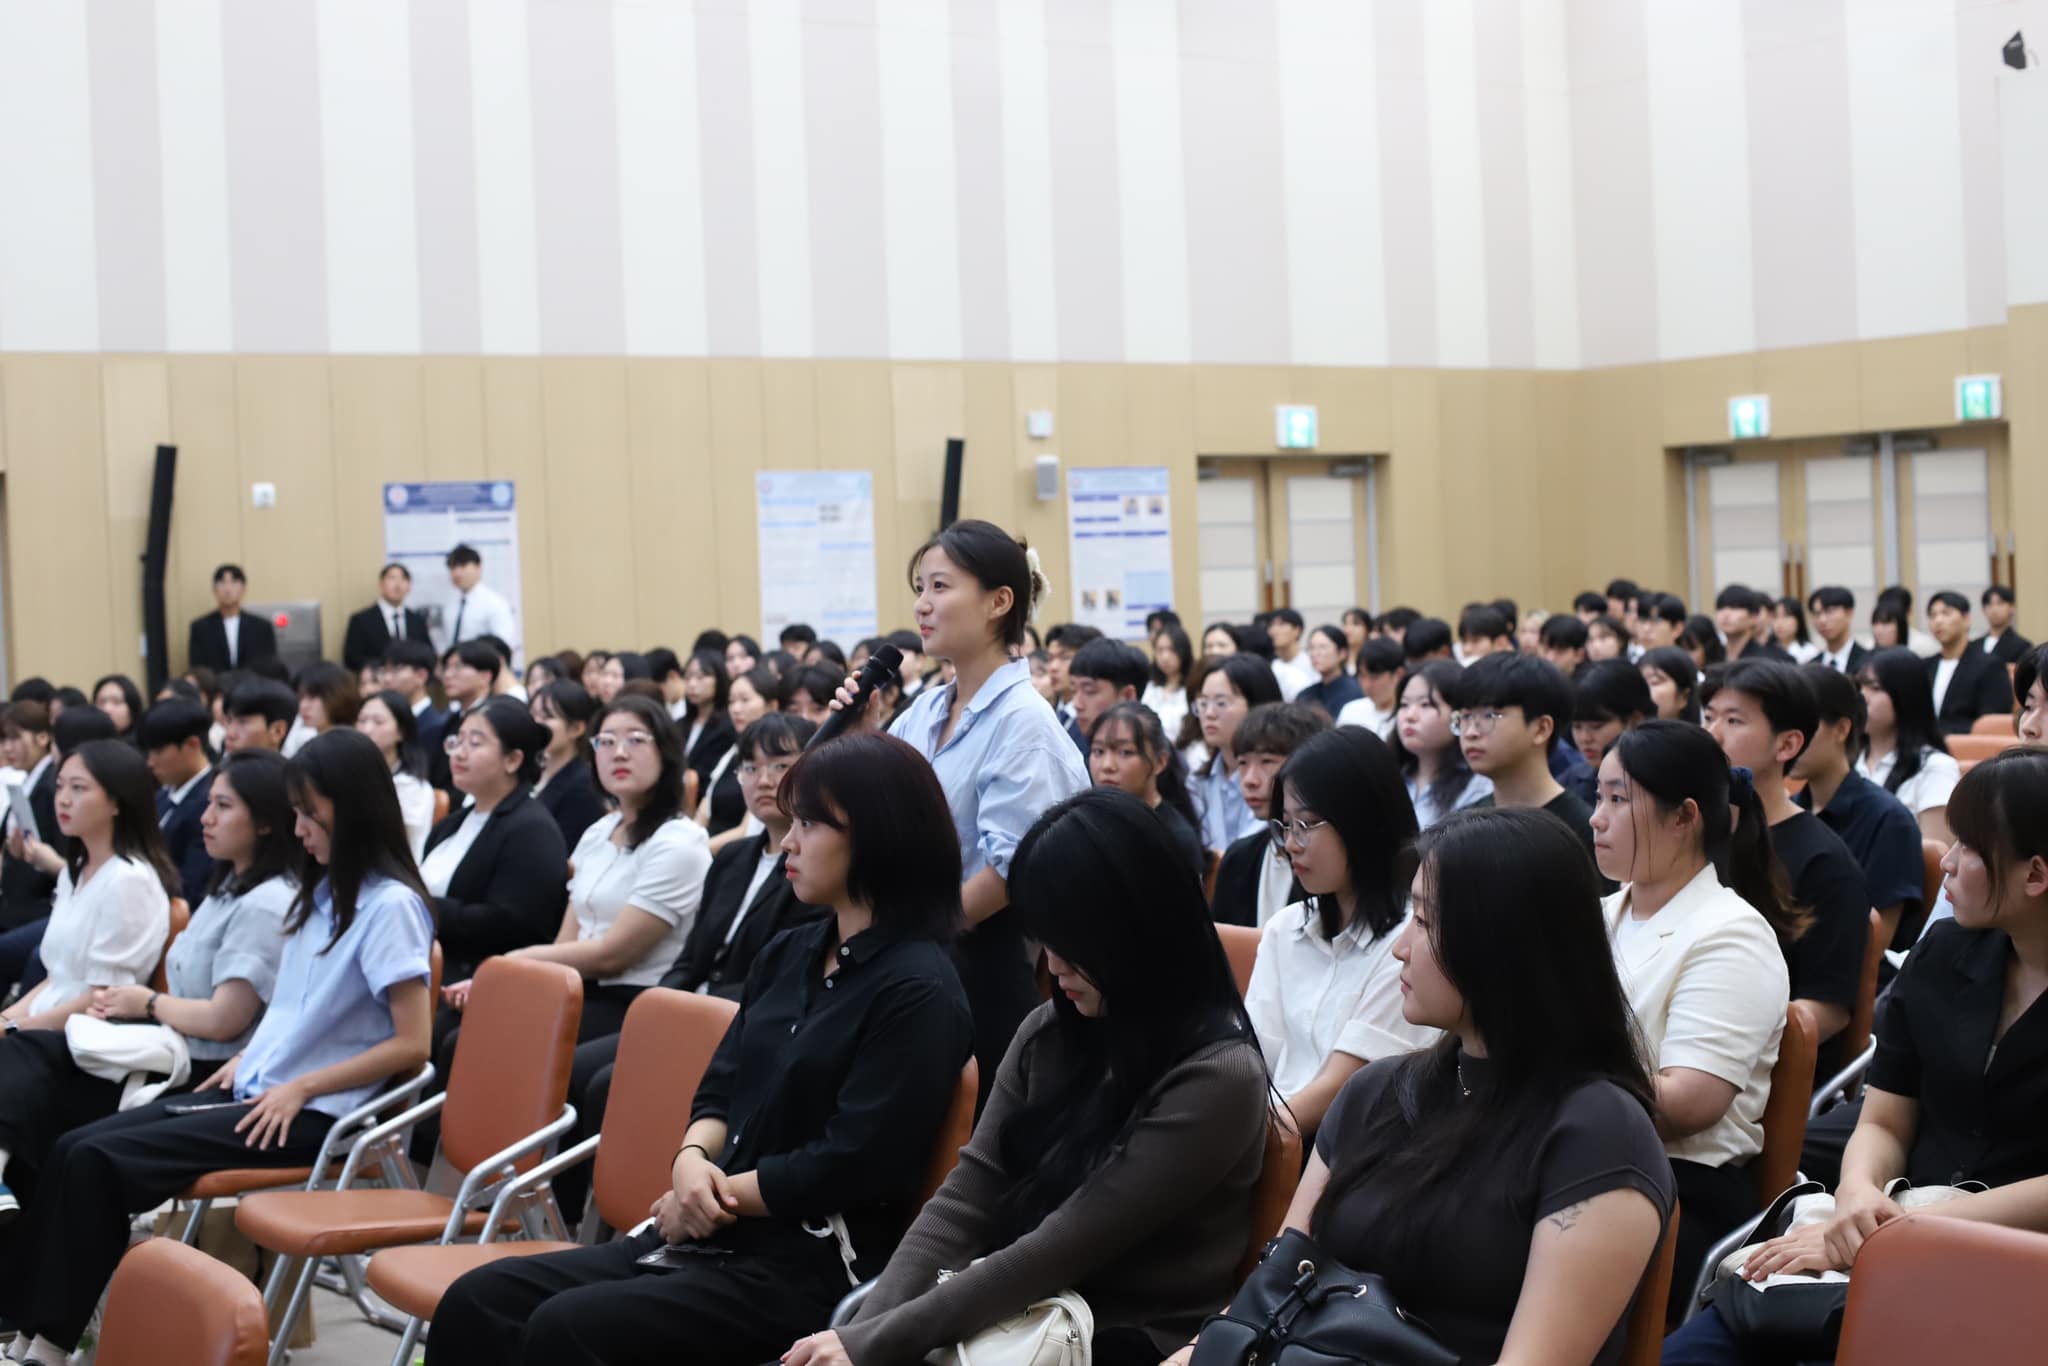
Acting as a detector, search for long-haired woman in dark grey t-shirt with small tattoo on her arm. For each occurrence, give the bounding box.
[1174,811,1673,1366]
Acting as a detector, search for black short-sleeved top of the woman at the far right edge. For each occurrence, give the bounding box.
[1870,920,2048,1186]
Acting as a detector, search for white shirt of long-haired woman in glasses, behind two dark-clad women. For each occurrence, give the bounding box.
[1245,901,1438,1096]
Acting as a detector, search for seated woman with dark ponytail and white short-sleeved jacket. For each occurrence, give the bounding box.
[1593,721,1798,1311]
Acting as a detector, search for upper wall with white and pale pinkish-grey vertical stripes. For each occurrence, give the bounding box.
[0,0,2048,369]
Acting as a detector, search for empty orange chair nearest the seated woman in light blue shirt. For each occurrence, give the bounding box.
[236,956,584,1366]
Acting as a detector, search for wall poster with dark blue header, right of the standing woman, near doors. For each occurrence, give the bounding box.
[1067,465,1174,641]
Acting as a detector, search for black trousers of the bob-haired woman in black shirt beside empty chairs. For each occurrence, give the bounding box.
[426,1221,852,1366]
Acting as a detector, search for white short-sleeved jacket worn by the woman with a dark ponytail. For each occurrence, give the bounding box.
[1599,864,1792,1167]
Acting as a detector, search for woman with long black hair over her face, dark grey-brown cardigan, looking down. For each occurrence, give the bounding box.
[806,791,1274,1366]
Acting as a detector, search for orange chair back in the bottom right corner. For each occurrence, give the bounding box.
[1835,1214,2048,1366]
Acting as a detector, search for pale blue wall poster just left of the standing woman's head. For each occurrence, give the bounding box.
[754,469,881,649]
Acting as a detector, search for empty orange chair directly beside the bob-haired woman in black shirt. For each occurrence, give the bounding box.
[369,987,741,1366]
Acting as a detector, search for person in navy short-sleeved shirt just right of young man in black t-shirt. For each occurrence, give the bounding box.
[1792,661,1927,950]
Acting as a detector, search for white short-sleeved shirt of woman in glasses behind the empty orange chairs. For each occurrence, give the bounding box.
[569,811,711,987]
